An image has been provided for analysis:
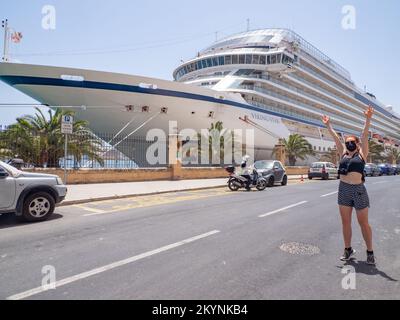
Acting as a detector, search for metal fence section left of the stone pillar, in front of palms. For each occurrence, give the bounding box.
[0,131,168,169]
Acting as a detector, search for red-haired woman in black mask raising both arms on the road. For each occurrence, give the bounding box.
[322,107,376,265]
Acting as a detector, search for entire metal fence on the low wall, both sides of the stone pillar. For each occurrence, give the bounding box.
[0,130,273,169]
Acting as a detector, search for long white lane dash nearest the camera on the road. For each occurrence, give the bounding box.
[7,230,220,300]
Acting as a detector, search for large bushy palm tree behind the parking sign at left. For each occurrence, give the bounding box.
[0,108,104,168]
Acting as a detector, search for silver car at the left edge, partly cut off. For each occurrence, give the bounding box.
[0,161,67,222]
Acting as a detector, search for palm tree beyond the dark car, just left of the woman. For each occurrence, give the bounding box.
[274,134,315,166]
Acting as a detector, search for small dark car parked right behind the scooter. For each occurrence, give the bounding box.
[254,160,288,187]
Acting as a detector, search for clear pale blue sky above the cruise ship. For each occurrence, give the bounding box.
[0,0,400,124]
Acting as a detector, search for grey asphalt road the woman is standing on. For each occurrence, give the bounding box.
[0,177,400,300]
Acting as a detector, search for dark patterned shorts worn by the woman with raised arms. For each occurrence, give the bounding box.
[338,181,370,210]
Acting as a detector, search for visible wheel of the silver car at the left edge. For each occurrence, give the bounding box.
[22,192,55,222]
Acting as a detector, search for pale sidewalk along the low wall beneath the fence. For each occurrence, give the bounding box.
[61,176,301,206]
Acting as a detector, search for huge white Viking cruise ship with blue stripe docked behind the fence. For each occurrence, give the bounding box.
[0,29,400,164]
